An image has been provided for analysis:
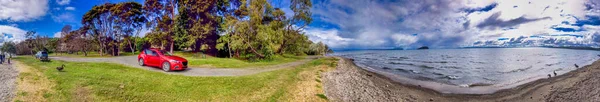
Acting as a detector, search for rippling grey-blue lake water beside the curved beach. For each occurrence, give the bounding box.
[333,48,600,94]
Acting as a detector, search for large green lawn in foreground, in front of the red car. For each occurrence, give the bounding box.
[15,57,335,102]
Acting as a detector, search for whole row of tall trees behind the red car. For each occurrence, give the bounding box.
[5,0,331,59]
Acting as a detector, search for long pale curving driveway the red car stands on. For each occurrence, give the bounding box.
[50,56,318,76]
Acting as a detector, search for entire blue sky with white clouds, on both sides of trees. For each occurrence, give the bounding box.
[0,0,600,50]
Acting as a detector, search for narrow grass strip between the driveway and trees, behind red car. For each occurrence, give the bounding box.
[174,52,304,68]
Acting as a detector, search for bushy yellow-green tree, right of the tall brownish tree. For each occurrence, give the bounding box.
[218,0,284,59]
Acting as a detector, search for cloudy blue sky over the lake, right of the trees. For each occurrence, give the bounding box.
[306,0,600,49]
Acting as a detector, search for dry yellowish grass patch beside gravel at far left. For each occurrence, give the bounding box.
[14,61,55,102]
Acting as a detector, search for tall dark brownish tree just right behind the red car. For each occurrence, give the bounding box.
[175,0,221,55]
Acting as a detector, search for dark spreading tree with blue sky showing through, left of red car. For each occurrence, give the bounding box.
[82,2,144,56]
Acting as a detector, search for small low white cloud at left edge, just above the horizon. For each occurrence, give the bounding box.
[0,25,27,43]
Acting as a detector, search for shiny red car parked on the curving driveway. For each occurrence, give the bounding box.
[138,48,187,72]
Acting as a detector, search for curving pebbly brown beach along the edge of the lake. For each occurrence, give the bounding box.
[324,57,600,101]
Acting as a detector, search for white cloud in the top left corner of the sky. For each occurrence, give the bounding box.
[0,0,48,22]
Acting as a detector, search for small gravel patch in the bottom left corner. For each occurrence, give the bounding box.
[0,63,19,102]
